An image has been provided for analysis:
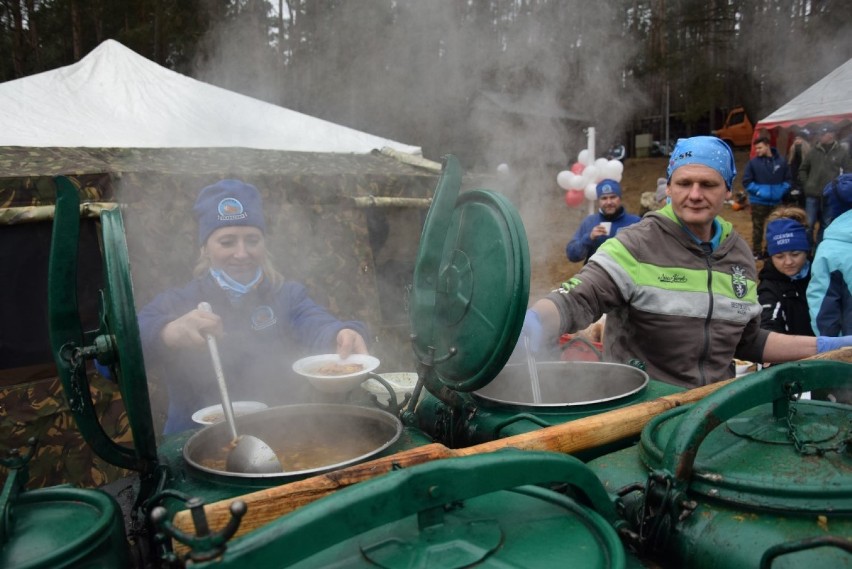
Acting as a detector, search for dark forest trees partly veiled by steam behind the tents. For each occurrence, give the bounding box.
[0,0,852,172]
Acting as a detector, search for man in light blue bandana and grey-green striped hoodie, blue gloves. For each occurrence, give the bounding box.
[516,136,852,387]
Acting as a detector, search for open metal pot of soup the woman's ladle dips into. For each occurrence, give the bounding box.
[183,404,402,479]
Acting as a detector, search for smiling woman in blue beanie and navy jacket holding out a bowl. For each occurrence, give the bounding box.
[138,180,368,434]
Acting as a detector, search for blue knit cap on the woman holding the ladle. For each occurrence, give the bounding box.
[192,180,266,245]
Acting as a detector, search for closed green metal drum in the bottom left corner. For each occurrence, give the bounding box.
[0,486,131,569]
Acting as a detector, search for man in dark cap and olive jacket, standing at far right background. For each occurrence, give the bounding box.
[799,124,852,243]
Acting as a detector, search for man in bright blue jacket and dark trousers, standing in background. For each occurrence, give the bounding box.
[743,136,790,259]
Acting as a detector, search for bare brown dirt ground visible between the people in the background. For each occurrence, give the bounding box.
[519,150,751,302]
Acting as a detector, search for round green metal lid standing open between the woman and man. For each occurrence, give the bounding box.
[410,156,530,391]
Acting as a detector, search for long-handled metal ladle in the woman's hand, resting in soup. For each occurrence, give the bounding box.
[198,302,284,474]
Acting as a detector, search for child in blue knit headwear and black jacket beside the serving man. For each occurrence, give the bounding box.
[757,207,814,336]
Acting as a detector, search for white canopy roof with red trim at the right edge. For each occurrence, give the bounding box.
[754,59,852,145]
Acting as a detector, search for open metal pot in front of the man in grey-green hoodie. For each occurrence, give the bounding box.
[474,361,648,407]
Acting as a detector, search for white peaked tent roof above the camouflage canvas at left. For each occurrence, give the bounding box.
[0,40,421,155]
